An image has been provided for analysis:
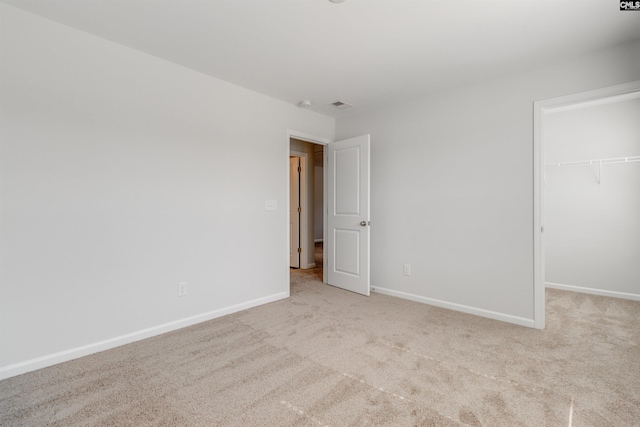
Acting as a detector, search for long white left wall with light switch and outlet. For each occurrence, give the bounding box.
[0,4,334,378]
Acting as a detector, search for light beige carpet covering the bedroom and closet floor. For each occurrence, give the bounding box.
[0,269,640,427]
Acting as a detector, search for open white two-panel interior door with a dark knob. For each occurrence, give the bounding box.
[325,135,370,296]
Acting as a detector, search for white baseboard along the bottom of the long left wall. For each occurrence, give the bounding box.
[0,292,289,380]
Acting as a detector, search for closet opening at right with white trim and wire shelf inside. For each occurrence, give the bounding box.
[534,82,640,328]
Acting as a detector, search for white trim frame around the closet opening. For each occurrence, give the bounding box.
[533,80,640,329]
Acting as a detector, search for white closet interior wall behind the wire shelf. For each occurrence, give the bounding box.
[544,99,640,299]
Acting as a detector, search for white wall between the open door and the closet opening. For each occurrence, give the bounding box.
[336,41,640,326]
